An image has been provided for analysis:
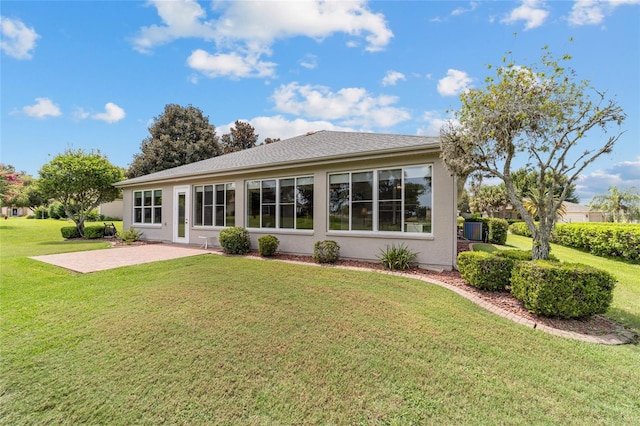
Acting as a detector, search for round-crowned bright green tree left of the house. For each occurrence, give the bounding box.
[39,149,124,236]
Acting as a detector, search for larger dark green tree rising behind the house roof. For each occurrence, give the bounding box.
[127,104,221,178]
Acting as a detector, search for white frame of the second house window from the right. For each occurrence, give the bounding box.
[245,174,315,233]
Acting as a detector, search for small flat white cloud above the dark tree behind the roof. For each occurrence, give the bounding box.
[187,49,276,79]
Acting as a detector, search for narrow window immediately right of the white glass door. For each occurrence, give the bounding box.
[193,183,236,226]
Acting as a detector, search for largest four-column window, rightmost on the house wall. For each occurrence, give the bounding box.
[329,165,432,233]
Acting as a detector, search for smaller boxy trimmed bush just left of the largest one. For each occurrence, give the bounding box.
[458,251,516,290]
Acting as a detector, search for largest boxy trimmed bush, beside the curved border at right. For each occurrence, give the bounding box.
[511,260,616,318]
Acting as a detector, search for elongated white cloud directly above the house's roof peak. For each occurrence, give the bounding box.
[272,82,411,127]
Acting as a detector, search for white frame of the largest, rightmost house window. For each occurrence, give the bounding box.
[326,163,434,238]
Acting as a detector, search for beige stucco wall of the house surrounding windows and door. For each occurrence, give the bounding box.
[123,153,457,269]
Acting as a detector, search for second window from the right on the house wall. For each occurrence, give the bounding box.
[247,176,313,229]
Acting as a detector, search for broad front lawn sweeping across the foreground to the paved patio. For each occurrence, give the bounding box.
[0,220,640,425]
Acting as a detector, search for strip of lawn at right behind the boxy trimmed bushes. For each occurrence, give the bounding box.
[474,234,640,332]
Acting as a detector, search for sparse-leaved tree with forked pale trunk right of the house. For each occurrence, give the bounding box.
[440,47,626,259]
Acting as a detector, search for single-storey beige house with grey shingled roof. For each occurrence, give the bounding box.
[116,131,457,269]
